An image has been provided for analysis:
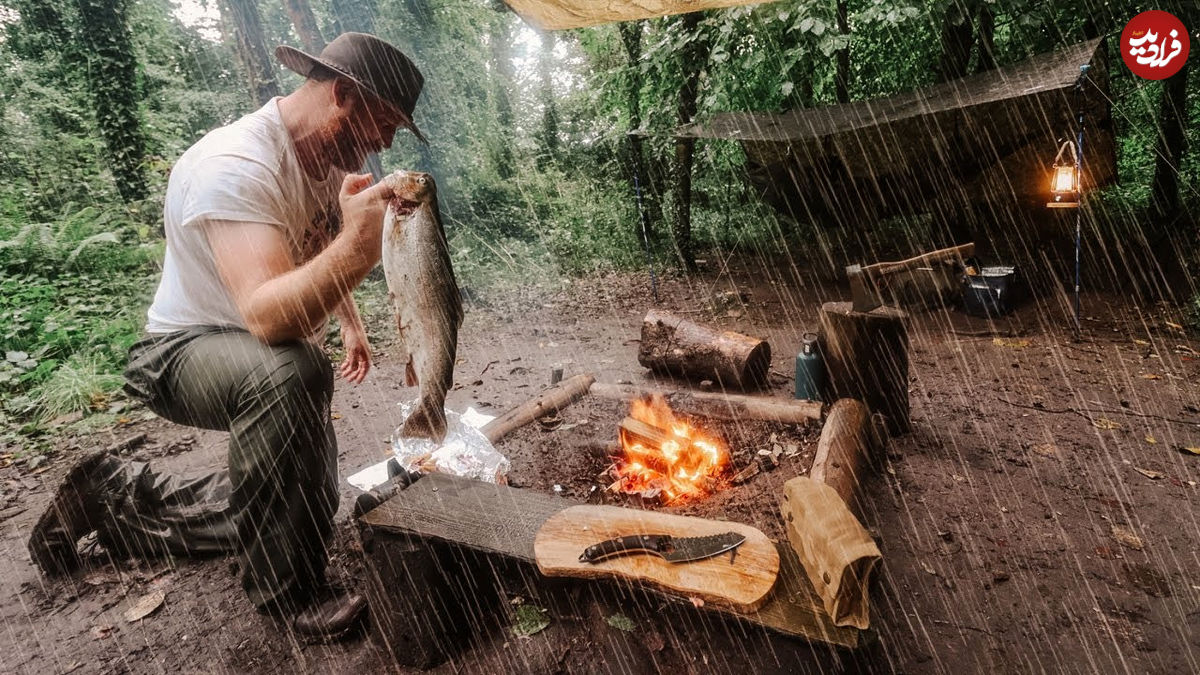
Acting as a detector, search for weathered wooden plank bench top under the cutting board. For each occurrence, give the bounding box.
[361,473,859,647]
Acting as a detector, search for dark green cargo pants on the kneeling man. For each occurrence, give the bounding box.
[118,328,337,608]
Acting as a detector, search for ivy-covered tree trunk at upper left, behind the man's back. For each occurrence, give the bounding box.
[78,0,149,203]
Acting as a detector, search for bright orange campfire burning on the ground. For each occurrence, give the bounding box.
[610,394,730,503]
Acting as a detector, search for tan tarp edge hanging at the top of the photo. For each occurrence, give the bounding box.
[504,0,763,30]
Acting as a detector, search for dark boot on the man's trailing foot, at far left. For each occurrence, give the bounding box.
[29,450,115,574]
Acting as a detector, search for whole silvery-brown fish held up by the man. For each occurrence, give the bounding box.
[383,171,462,443]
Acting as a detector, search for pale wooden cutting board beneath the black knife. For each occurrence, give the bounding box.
[533,506,779,613]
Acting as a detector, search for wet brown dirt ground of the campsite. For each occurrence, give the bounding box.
[0,260,1200,673]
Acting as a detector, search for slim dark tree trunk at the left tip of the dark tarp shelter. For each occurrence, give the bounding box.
[673,12,708,273]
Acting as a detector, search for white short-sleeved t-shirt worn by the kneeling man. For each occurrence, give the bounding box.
[146,98,344,334]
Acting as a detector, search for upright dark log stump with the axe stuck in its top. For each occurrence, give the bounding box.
[821,303,911,436]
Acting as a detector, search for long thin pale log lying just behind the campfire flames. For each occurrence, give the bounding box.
[590,382,822,424]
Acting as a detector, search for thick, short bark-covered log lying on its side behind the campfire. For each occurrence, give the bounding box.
[637,310,770,389]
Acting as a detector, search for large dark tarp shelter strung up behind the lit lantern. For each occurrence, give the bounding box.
[676,38,1116,225]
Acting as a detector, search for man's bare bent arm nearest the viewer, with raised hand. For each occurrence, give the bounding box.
[206,175,391,345]
